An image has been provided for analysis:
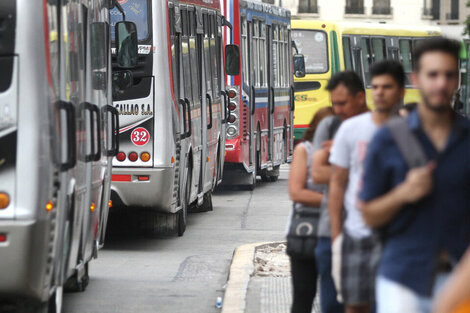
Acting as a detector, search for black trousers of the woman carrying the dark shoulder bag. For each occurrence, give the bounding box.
[290,258,318,313]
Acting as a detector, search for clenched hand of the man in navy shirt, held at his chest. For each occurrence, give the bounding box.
[402,162,436,203]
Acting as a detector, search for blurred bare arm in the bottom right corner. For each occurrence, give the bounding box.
[434,248,470,313]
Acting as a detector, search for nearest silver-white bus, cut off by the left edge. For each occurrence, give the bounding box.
[0,0,137,313]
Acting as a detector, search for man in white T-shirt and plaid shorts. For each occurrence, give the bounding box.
[329,60,405,313]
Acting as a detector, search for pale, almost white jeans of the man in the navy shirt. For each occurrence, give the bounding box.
[376,274,448,313]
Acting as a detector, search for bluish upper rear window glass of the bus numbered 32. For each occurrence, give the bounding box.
[109,0,149,42]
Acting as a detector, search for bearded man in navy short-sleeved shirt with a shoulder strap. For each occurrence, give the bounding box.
[360,38,470,313]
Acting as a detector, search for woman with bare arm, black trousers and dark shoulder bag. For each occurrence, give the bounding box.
[287,107,333,313]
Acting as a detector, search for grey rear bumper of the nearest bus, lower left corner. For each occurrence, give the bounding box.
[0,220,52,301]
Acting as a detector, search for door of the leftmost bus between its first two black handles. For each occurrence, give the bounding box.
[59,1,94,282]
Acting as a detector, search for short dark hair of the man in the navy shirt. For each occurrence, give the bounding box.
[413,37,462,71]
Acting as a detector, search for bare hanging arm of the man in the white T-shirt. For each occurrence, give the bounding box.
[328,165,349,241]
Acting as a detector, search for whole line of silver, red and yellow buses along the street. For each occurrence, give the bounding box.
[0,0,456,313]
